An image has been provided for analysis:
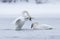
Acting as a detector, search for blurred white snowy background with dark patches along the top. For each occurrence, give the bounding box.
[0,0,60,18]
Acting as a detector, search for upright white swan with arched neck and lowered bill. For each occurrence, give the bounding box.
[14,11,32,30]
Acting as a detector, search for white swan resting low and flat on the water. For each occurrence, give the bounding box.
[31,22,53,30]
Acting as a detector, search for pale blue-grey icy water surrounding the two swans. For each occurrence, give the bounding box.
[0,18,60,40]
